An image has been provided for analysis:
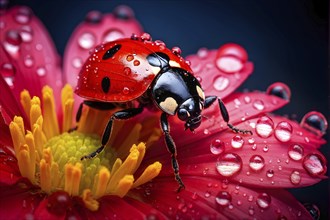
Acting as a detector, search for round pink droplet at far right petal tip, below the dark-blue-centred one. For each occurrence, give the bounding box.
[303,153,327,177]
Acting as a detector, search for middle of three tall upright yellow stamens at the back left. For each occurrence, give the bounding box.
[42,86,60,139]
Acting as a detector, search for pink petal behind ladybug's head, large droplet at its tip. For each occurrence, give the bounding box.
[187,44,253,98]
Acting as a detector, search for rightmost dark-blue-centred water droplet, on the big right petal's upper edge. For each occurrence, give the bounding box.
[300,111,328,137]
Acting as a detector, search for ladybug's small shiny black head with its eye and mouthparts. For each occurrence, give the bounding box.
[177,97,203,131]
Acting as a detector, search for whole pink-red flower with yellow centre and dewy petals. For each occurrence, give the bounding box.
[0,3,327,219]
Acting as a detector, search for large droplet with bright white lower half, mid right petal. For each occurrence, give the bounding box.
[216,153,242,177]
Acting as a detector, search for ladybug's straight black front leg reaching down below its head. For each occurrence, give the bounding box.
[160,112,185,192]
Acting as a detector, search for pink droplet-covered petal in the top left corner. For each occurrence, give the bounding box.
[0,6,62,98]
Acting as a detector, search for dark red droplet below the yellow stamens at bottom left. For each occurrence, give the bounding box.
[46,191,71,215]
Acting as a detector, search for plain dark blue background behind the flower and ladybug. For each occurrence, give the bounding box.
[10,0,330,219]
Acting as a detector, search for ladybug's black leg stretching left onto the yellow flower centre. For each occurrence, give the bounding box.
[81,107,143,160]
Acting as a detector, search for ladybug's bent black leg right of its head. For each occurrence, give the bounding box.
[204,96,253,135]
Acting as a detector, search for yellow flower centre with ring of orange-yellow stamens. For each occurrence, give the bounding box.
[9,85,161,210]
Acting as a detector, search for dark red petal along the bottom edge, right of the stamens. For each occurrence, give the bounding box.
[133,177,312,219]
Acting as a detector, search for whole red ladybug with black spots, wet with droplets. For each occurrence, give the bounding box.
[75,34,252,191]
